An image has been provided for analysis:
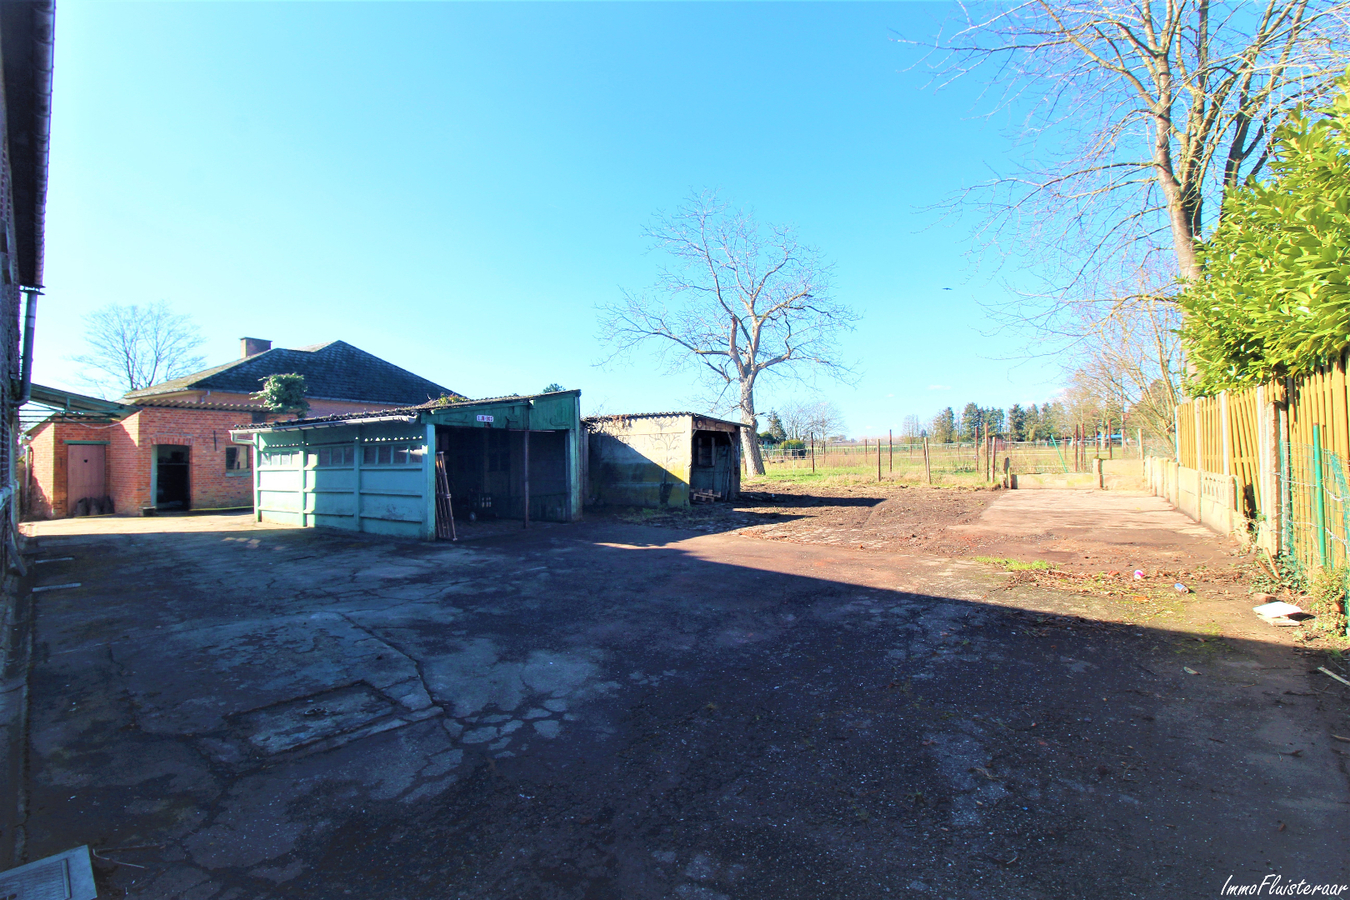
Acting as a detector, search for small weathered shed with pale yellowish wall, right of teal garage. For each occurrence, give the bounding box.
[585,413,744,507]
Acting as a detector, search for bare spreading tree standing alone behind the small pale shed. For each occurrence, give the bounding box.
[601,193,857,475]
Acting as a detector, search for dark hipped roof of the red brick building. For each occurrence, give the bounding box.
[123,340,462,406]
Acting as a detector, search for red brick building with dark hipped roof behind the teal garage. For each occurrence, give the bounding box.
[23,337,460,518]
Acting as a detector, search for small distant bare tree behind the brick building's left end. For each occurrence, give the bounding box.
[72,301,204,394]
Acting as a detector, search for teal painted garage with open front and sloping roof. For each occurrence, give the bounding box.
[231,391,582,540]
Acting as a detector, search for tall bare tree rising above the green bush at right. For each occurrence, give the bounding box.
[909,0,1350,394]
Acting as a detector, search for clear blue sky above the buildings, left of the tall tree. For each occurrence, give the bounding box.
[35,0,1058,436]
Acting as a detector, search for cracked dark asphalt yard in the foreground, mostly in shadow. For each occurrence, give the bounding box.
[10,512,1350,900]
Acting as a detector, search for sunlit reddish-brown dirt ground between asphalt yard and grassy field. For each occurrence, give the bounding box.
[602,480,1337,649]
